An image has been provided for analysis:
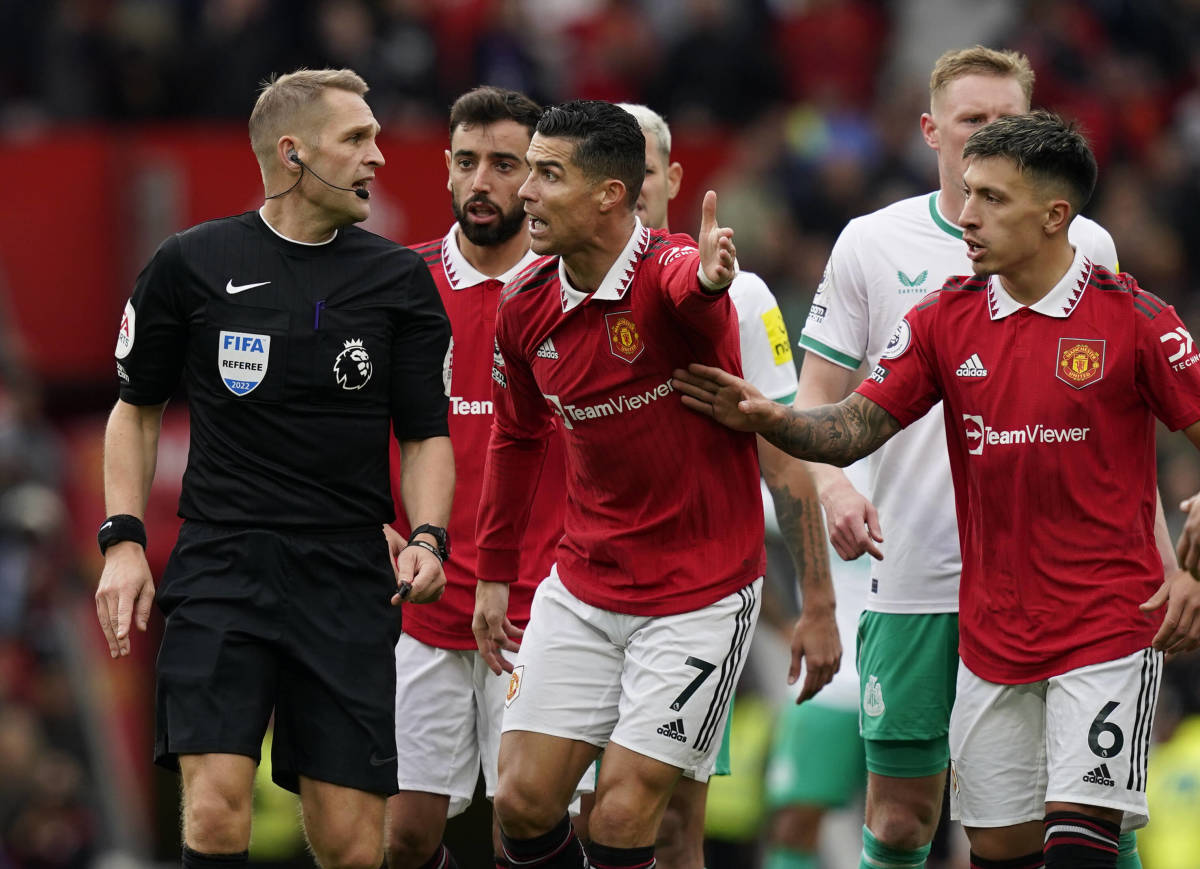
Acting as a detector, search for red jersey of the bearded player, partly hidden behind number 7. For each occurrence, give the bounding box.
[391,227,566,649]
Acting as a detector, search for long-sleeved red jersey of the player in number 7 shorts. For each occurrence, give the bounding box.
[479,222,764,616]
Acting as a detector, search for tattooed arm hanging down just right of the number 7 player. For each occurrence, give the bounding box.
[758,436,841,703]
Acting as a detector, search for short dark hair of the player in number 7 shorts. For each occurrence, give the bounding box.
[538,100,646,211]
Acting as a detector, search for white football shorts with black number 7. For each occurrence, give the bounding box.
[504,570,762,781]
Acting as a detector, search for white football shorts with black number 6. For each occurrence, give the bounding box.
[950,648,1163,831]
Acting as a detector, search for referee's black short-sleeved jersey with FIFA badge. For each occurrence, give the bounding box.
[116,211,450,529]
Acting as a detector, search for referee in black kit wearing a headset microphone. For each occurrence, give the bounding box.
[96,70,454,869]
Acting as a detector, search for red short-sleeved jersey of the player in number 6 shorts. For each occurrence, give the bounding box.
[858,253,1200,684]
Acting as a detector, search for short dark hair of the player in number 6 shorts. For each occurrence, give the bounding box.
[962,109,1097,214]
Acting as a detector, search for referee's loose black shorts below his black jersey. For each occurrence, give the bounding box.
[155,521,400,795]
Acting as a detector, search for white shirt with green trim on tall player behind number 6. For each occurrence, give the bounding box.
[799,191,1117,612]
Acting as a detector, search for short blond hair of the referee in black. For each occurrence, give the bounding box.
[250,70,367,166]
